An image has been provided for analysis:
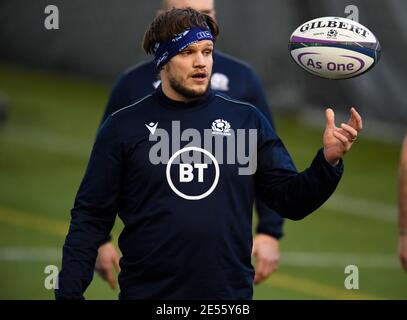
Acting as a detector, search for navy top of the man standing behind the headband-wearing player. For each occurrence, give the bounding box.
[102,51,284,239]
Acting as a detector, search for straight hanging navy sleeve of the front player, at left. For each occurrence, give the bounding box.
[55,117,123,299]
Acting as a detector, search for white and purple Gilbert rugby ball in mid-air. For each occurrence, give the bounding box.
[289,17,381,79]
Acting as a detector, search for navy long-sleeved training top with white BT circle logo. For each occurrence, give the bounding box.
[55,87,343,299]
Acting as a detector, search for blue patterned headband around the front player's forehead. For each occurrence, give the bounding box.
[153,27,213,70]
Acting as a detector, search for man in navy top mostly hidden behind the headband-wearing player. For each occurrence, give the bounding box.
[95,0,284,288]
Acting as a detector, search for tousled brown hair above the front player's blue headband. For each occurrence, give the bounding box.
[143,8,219,54]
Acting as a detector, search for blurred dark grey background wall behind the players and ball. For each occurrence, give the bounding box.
[0,0,407,139]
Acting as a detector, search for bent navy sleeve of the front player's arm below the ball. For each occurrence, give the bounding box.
[255,112,343,220]
